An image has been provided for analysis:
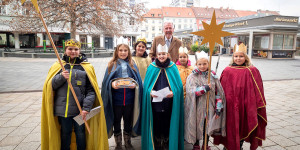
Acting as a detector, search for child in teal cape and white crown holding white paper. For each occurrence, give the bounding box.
[142,44,184,150]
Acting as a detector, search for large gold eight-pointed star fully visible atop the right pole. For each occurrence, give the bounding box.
[191,11,233,54]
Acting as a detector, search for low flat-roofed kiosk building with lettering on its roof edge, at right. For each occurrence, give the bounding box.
[223,13,299,59]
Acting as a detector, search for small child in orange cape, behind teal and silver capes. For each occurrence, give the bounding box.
[176,47,194,98]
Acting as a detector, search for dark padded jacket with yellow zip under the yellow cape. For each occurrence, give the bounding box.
[52,54,95,117]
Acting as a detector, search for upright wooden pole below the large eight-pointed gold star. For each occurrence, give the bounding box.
[204,43,214,150]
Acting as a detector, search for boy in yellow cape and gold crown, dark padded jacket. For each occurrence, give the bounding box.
[41,39,108,150]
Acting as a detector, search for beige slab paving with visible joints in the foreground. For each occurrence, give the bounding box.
[0,80,300,150]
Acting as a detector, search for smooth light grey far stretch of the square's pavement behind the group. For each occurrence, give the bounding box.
[0,55,300,92]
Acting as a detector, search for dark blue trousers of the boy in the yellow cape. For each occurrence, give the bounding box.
[58,116,86,150]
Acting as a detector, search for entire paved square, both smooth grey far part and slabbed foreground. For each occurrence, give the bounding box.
[0,56,300,150]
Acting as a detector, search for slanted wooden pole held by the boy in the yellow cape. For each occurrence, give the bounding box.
[38,6,91,134]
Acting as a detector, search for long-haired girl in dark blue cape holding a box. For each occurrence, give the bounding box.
[101,44,142,150]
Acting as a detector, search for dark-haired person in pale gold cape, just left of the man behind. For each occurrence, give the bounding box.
[132,38,152,82]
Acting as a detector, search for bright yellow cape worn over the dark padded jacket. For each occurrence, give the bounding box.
[41,62,109,150]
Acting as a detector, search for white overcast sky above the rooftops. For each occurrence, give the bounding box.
[142,0,300,16]
